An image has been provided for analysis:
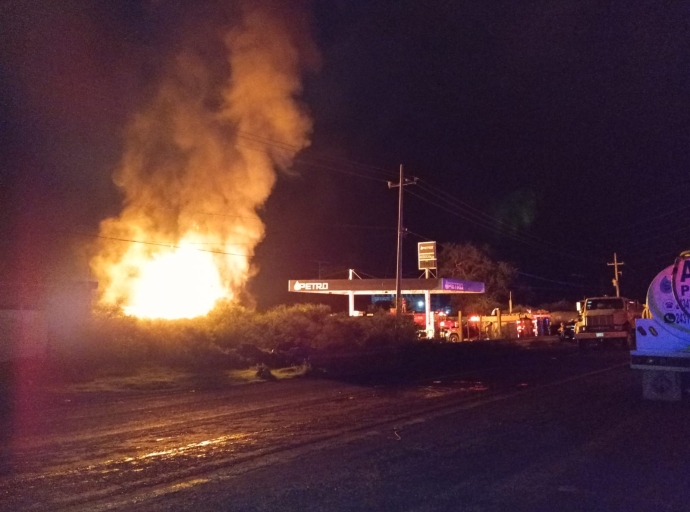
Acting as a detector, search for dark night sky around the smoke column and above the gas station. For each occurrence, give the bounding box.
[0,0,690,307]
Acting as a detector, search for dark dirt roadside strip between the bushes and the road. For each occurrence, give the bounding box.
[0,338,574,402]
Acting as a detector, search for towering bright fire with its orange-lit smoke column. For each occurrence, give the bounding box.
[91,2,311,319]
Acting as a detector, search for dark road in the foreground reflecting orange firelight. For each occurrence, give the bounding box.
[0,346,690,512]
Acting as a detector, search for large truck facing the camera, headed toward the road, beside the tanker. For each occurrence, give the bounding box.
[574,297,642,348]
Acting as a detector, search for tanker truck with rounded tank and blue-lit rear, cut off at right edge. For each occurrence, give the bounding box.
[630,251,690,401]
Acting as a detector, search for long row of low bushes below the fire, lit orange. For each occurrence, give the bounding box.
[53,304,415,368]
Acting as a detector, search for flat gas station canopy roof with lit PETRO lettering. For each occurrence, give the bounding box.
[288,278,484,295]
